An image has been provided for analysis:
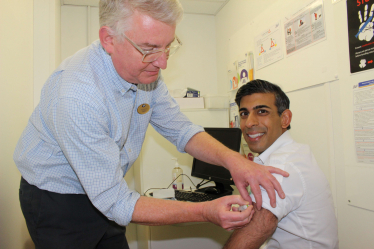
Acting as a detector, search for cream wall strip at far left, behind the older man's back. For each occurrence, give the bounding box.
[0,0,33,249]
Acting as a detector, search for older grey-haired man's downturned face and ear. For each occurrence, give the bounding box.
[99,11,175,84]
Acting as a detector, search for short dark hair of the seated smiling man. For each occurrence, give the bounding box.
[235,79,291,130]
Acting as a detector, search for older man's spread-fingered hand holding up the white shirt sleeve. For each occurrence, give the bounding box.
[227,154,289,209]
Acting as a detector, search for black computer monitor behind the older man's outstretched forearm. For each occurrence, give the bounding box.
[191,128,242,196]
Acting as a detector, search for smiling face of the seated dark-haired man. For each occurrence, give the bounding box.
[239,93,292,154]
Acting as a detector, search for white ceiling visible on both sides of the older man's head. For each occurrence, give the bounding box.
[61,0,230,15]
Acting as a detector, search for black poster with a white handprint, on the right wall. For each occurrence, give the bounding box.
[347,0,374,73]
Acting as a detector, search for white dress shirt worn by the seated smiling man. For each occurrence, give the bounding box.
[251,131,339,249]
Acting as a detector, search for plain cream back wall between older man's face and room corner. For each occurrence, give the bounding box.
[162,14,217,95]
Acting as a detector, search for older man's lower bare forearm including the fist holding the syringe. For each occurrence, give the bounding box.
[131,195,252,230]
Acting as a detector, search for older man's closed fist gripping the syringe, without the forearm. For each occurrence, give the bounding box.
[203,195,254,231]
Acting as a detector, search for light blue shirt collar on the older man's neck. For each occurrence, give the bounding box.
[100,44,138,95]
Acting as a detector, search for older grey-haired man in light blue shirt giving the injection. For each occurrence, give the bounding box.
[14,0,287,249]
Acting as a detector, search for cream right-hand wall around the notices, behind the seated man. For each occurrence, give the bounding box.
[216,0,374,249]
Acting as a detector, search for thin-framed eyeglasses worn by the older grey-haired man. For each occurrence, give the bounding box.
[123,34,182,63]
